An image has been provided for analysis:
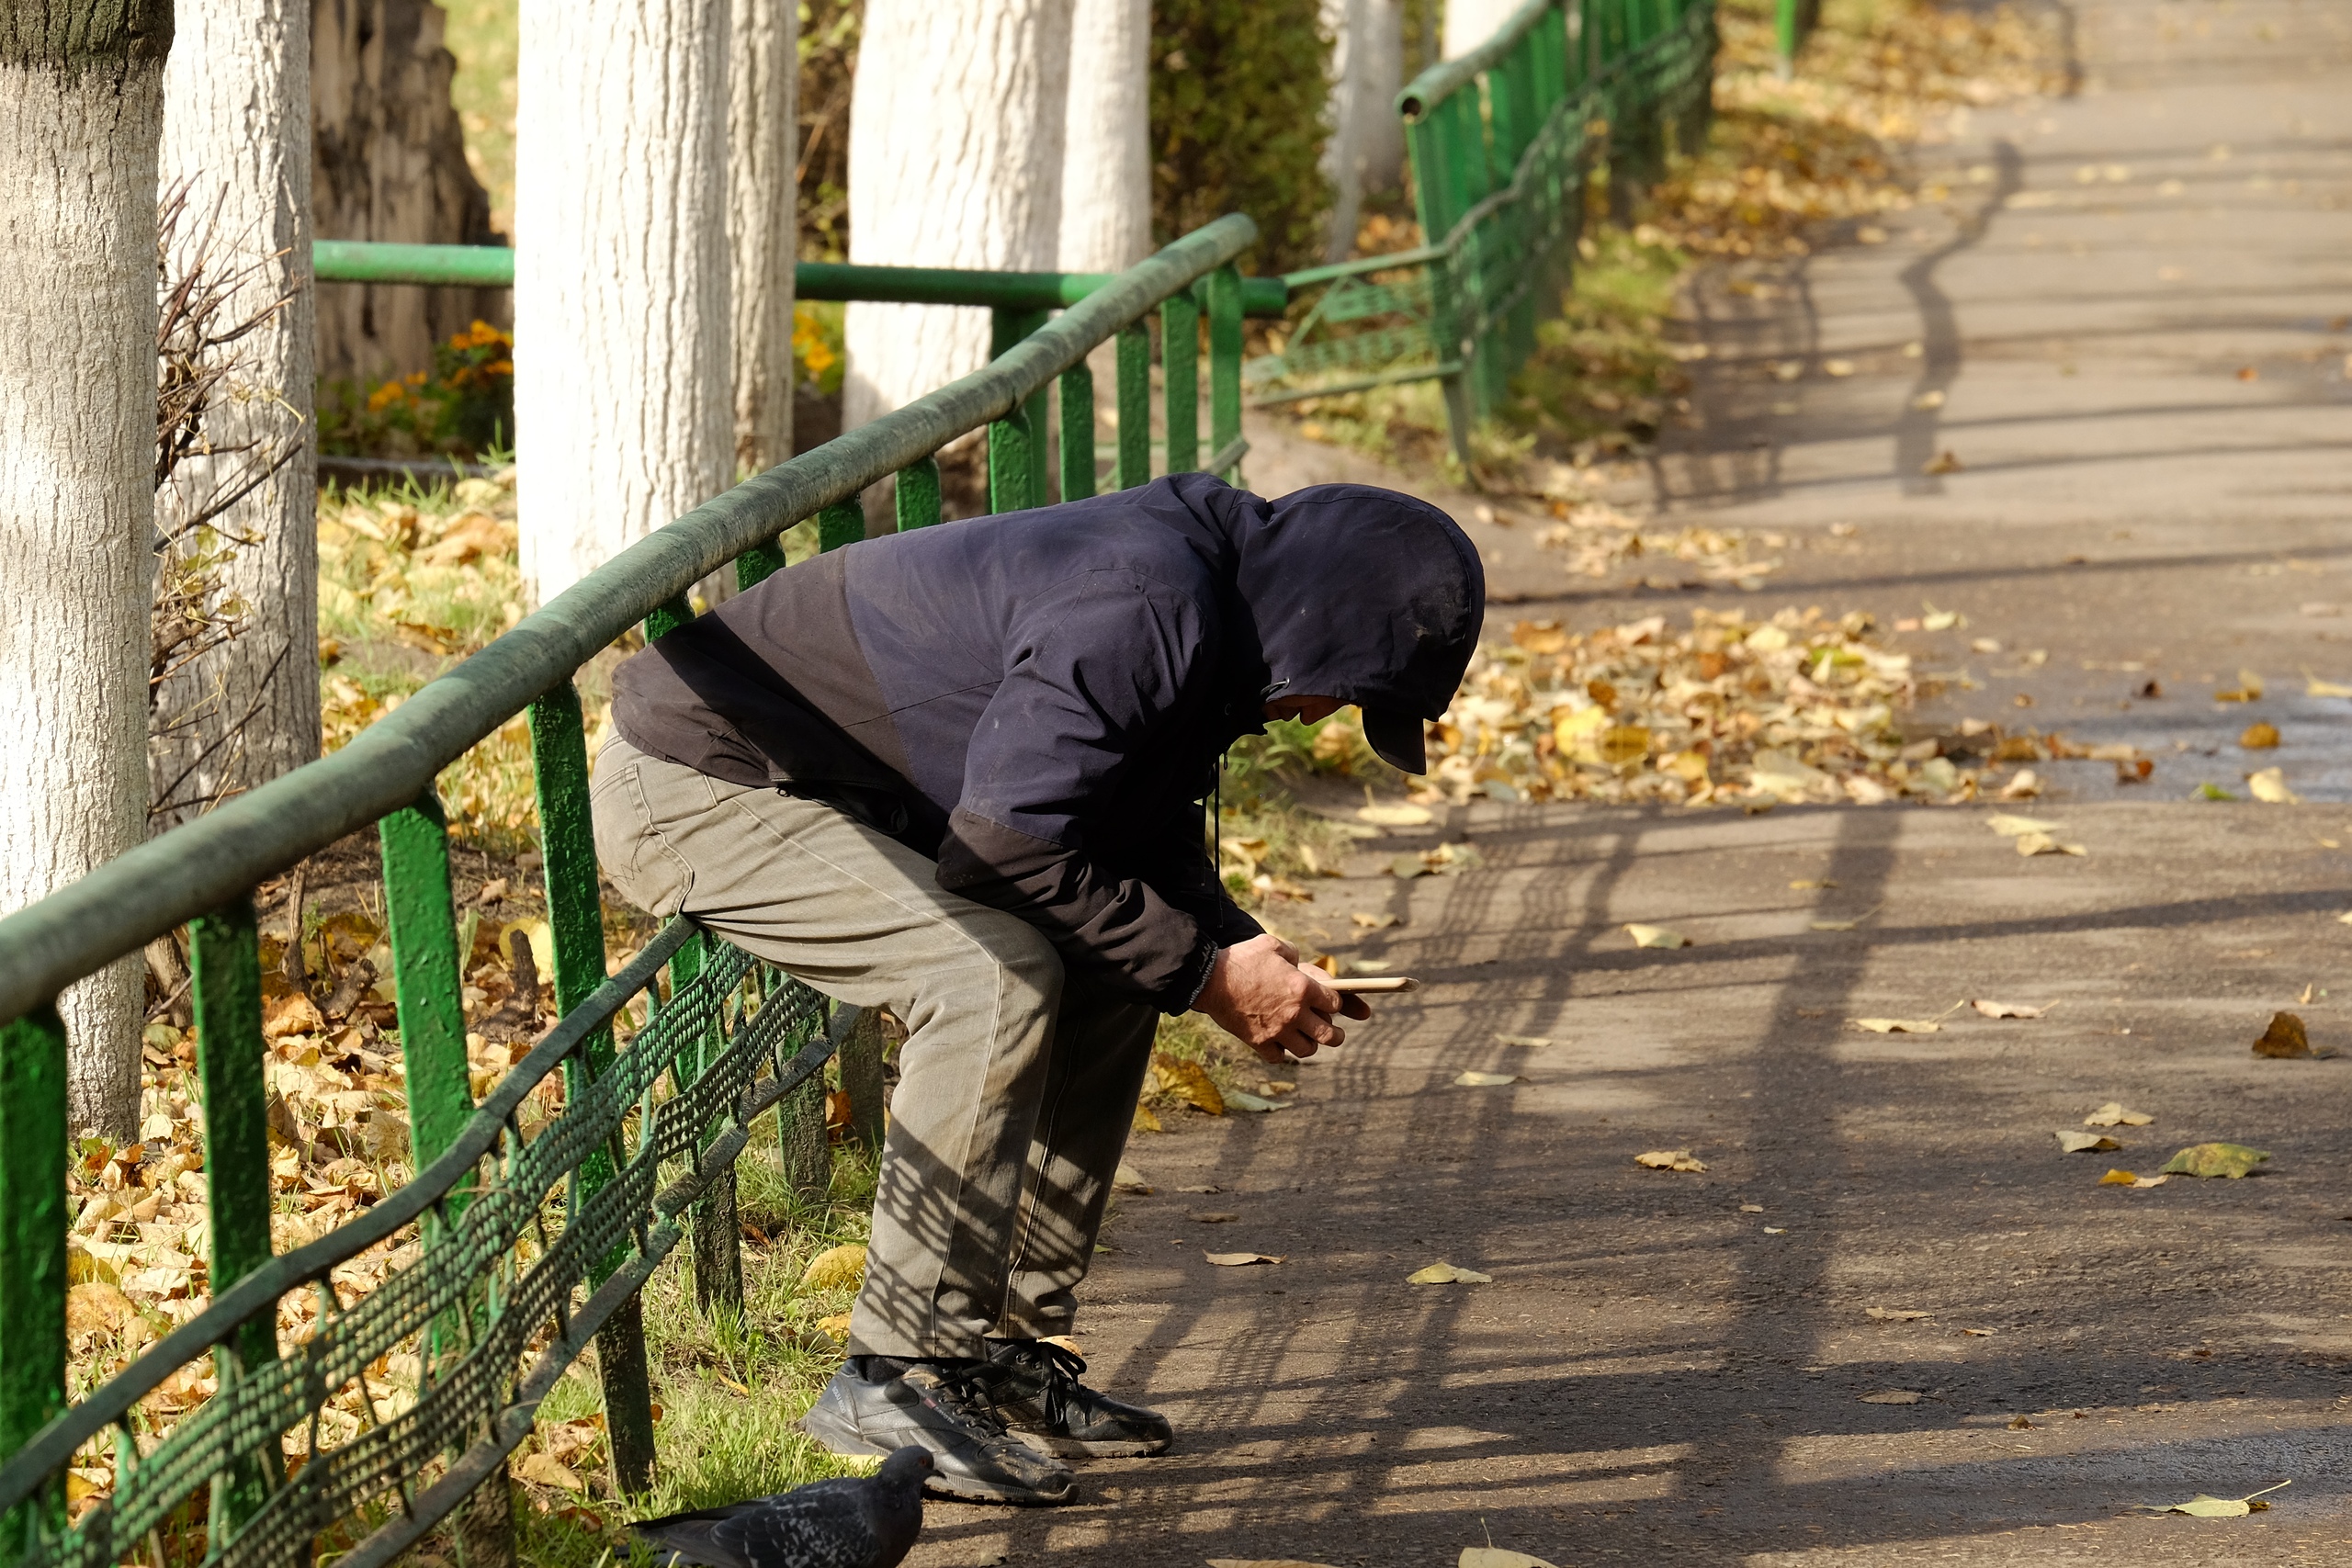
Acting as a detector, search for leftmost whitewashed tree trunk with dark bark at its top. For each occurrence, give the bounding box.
[0,0,172,1138]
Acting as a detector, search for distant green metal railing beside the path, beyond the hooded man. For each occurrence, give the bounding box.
[1244,0,1717,463]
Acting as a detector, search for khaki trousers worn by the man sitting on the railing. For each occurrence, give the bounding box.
[591,740,1158,1357]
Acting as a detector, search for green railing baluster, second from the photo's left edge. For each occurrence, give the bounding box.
[188,898,277,1554]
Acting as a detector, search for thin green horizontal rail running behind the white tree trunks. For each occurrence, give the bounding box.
[311,240,1289,315]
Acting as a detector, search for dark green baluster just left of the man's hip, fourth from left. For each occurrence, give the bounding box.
[529,682,653,1491]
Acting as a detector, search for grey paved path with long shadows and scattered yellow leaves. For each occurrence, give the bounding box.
[910,0,2352,1568]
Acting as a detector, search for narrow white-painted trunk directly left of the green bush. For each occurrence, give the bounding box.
[1058,0,1152,273]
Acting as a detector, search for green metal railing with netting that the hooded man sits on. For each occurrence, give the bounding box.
[0,216,1256,1568]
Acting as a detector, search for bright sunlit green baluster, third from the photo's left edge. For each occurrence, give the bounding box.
[377,790,473,1213]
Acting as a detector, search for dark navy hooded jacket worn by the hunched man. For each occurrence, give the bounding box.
[614,472,1484,1010]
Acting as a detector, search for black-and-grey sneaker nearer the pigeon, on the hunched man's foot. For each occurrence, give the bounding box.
[799,1357,1072,1502]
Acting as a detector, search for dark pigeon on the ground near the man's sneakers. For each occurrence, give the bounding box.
[630,1448,932,1568]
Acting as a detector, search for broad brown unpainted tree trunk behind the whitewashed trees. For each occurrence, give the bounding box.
[311,0,513,381]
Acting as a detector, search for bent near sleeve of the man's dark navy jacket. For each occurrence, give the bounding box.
[938,571,1247,1013]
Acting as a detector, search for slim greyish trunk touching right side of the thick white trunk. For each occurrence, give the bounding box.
[727,0,799,472]
